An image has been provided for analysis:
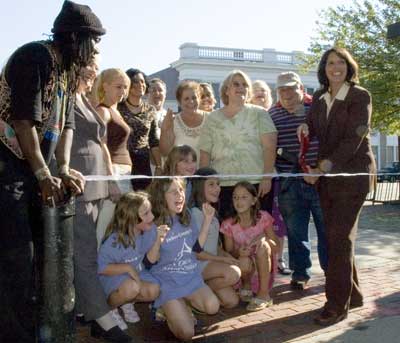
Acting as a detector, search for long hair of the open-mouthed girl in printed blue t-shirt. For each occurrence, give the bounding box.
[149,177,190,226]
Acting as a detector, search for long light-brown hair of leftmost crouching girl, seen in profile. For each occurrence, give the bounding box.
[102,192,149,248]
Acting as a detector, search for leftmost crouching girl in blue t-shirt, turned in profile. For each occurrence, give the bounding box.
[98,192,169,330]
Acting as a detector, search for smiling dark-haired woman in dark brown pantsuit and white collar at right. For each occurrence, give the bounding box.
[298,48,376,326]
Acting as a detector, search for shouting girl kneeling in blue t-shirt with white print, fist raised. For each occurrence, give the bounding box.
[145,178,219,340]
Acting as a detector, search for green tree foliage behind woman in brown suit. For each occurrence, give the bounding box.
[304,0,400,135]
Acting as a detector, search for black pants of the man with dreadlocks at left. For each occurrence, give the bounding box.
[0,143,40,342]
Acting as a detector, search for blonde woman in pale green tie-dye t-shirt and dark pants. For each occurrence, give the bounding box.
[199,70,277,219]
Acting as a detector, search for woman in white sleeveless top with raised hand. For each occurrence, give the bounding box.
[160,81,206,165]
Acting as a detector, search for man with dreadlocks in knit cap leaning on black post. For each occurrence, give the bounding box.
[0,1,130,342]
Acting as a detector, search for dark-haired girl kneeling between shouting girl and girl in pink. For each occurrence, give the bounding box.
[190,167,240,308]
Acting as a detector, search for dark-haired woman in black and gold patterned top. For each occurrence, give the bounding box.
[118,68,161,190]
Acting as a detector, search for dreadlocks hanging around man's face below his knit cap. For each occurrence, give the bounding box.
[53,32,99,94]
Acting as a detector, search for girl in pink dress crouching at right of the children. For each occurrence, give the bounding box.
[220,181,279,311]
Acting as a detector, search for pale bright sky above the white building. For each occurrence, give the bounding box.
[0,0,350,74]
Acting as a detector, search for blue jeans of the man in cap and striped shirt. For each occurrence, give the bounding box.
[278,178,328,281]
